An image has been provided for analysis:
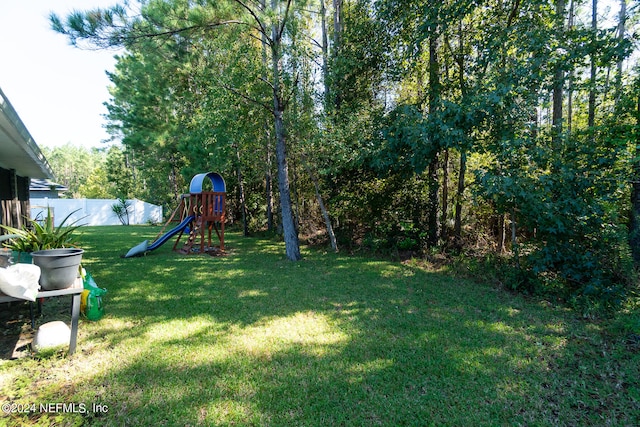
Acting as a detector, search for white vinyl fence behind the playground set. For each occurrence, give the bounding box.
[29,198,162,227]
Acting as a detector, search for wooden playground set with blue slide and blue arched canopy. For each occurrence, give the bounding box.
[124,172,226,258]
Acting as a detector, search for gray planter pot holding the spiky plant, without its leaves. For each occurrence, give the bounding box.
[31,248,84,291]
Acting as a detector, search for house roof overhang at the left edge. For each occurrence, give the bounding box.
[0,89,53,178]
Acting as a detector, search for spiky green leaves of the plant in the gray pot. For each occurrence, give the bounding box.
[0,209,85,252]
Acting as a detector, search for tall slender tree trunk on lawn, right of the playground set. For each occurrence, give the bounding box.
[271,0,302,261]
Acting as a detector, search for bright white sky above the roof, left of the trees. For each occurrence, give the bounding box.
[0,0,117,147]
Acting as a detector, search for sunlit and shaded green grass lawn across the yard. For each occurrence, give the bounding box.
[0,226,640,426]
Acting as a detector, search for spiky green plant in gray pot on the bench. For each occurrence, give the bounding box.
[0,209,84,290]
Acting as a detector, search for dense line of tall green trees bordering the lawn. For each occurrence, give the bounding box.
[51,0,640,309]
